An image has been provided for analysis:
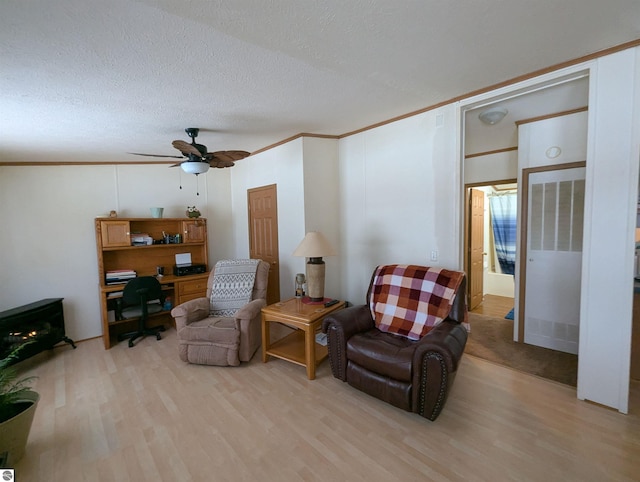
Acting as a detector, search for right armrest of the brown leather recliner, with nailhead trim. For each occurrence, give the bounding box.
[412,319,467,420]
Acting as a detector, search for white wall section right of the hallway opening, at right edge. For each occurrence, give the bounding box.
[578,48,640,412]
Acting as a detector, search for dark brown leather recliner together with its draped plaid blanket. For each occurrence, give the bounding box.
[322,265,467,420]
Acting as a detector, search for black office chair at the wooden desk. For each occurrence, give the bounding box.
[118,276,164,347]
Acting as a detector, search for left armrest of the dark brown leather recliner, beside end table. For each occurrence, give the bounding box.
[322,305,375,382]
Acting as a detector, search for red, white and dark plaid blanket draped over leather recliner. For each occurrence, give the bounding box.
[369,264,464,340]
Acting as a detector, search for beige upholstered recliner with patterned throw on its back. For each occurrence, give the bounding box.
[171,259,269,366]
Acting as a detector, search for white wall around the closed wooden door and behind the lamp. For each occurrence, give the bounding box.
[231,137,341,299]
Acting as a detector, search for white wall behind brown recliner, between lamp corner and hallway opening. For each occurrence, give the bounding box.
[339,105,461,304]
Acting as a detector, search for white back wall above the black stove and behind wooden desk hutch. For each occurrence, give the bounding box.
[0,165,208,340]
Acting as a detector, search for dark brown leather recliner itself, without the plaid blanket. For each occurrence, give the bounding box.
[322,266,467,420]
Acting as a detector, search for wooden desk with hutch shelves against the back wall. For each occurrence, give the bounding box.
[95,218,209,349]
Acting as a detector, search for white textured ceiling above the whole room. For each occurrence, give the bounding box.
[0,0,640,162]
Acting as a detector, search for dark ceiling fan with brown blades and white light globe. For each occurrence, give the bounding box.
[129,127,250,176]
